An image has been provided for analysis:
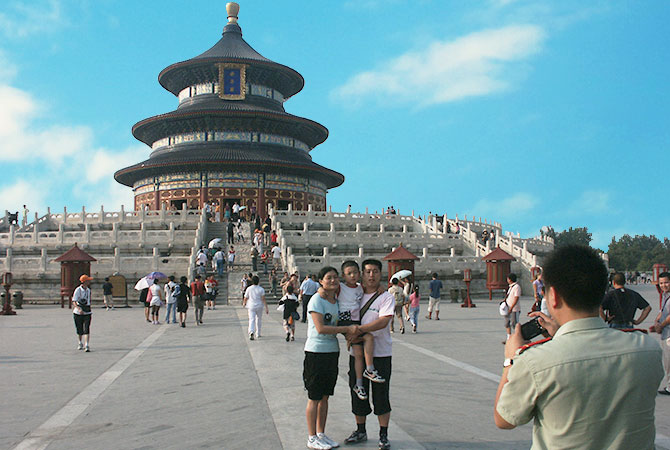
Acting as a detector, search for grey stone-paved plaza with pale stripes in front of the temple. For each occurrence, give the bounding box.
[0,286,670,450]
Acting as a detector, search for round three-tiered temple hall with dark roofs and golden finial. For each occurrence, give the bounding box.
[114,3,344,215]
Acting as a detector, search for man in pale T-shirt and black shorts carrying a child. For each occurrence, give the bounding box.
[345,259,395,450]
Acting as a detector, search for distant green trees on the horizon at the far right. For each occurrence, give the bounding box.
[544,227,670,272]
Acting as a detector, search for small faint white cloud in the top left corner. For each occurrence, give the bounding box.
[0,0,67,39]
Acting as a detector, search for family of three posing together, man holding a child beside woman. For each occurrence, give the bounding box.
[303,259,395,450]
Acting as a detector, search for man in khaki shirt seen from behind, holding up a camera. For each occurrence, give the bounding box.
[494,246,663,449]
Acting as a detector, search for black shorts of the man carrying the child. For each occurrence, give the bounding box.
[349,355,391,416]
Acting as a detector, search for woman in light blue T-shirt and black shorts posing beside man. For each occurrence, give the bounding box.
[306,267,357,450]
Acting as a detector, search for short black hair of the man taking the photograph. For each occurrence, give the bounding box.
[543,245,607,312]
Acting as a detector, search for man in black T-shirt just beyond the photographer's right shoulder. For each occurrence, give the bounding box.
[600,272,651,329]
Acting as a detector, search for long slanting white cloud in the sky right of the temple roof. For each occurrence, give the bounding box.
[331,25,544,106]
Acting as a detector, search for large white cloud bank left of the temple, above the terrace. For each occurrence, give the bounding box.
[0,48,138,215]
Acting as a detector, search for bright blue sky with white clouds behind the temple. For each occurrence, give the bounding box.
[0,0,670,248]
